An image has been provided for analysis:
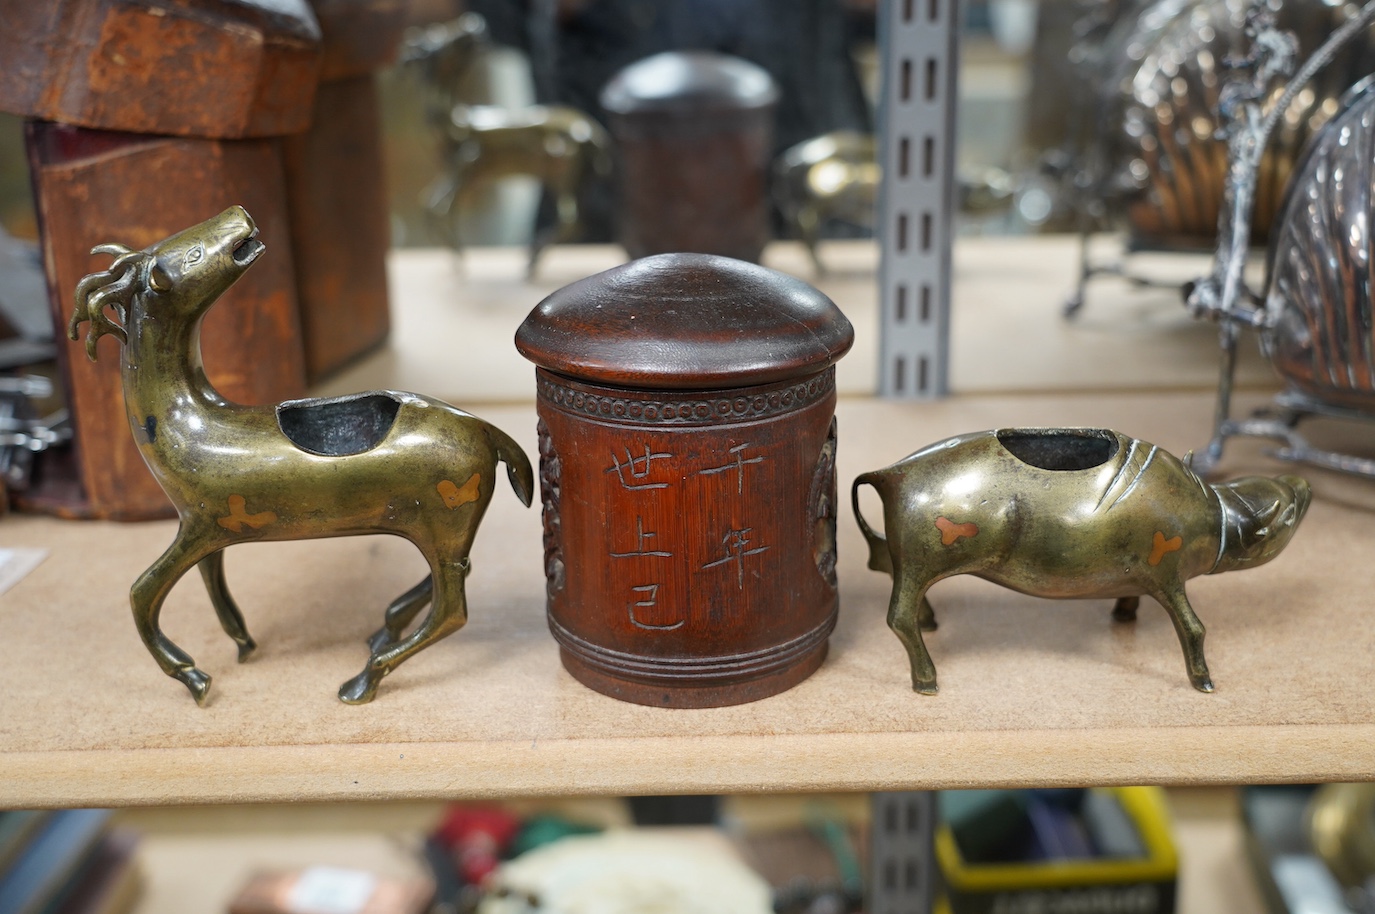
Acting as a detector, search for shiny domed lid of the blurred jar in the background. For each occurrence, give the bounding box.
[601,51,778,114]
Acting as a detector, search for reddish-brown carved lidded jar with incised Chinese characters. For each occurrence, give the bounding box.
[516,254,854,708]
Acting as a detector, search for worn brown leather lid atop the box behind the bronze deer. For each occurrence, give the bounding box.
[0,0,320,139]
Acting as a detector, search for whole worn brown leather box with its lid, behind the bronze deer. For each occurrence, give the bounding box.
[0,0,325,520]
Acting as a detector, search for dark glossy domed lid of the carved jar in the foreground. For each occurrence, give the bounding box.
[516,254,854,390]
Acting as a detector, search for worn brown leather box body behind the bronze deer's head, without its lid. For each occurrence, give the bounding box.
[18,121,305,520]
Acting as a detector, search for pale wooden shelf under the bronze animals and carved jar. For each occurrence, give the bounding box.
[0,392,1375,807]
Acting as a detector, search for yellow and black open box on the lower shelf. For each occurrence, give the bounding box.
[935,788,1178,914]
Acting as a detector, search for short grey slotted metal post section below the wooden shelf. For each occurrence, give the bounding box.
[865,790,936,914]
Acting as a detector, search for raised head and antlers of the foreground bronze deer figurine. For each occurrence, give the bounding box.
[67,206,264,361]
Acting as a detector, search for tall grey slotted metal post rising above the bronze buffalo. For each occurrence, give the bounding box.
[879,0,960,399]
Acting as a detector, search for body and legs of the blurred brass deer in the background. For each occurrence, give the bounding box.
[425,104,612,276]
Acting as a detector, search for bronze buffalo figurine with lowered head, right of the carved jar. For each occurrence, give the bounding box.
[851,429,1310,694]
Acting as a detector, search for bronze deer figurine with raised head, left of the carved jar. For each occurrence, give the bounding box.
[67,206,534,704]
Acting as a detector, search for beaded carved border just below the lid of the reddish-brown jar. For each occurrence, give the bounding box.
[536,367,836,425]
